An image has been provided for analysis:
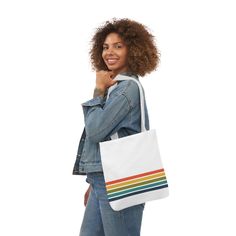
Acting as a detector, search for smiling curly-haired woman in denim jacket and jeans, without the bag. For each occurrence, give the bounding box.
[73,19,159,236]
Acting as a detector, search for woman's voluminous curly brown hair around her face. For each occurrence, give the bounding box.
[90,18,160,76]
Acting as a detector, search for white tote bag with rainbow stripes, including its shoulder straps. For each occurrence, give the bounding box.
[99,75,169,211]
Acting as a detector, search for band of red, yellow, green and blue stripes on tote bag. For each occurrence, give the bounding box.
[106,169,168,202]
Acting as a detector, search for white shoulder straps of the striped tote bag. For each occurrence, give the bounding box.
[106,75,146,139]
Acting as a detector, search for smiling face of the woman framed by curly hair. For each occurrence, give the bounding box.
[102,33,128,74]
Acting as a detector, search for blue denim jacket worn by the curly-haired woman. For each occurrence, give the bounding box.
[73,73,149,175]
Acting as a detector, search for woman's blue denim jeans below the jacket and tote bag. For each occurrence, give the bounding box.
[80,172,145,236]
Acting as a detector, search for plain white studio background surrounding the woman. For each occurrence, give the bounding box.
[0,0,236,236]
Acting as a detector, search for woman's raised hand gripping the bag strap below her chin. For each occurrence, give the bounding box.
[96,70,117,91]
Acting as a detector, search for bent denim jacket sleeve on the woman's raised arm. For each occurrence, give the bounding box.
[82,83,132,142]
